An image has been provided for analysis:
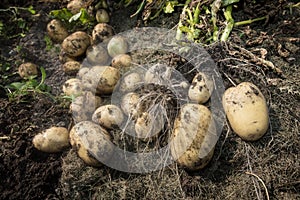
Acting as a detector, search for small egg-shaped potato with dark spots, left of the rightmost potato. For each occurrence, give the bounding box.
[188,72,213,104]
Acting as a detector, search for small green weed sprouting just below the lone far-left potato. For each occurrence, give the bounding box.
[5,67,54,101]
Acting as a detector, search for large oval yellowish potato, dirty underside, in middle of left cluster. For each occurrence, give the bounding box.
[82,66,120,94]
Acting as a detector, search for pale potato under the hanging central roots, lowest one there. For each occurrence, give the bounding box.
[134,112,164,140]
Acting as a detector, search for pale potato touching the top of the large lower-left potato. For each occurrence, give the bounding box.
[70,91,102,122]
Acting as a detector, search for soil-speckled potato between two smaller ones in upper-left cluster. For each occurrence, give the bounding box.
[61,31,90,57]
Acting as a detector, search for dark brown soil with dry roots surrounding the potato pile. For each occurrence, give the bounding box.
[0,0,300,199]
